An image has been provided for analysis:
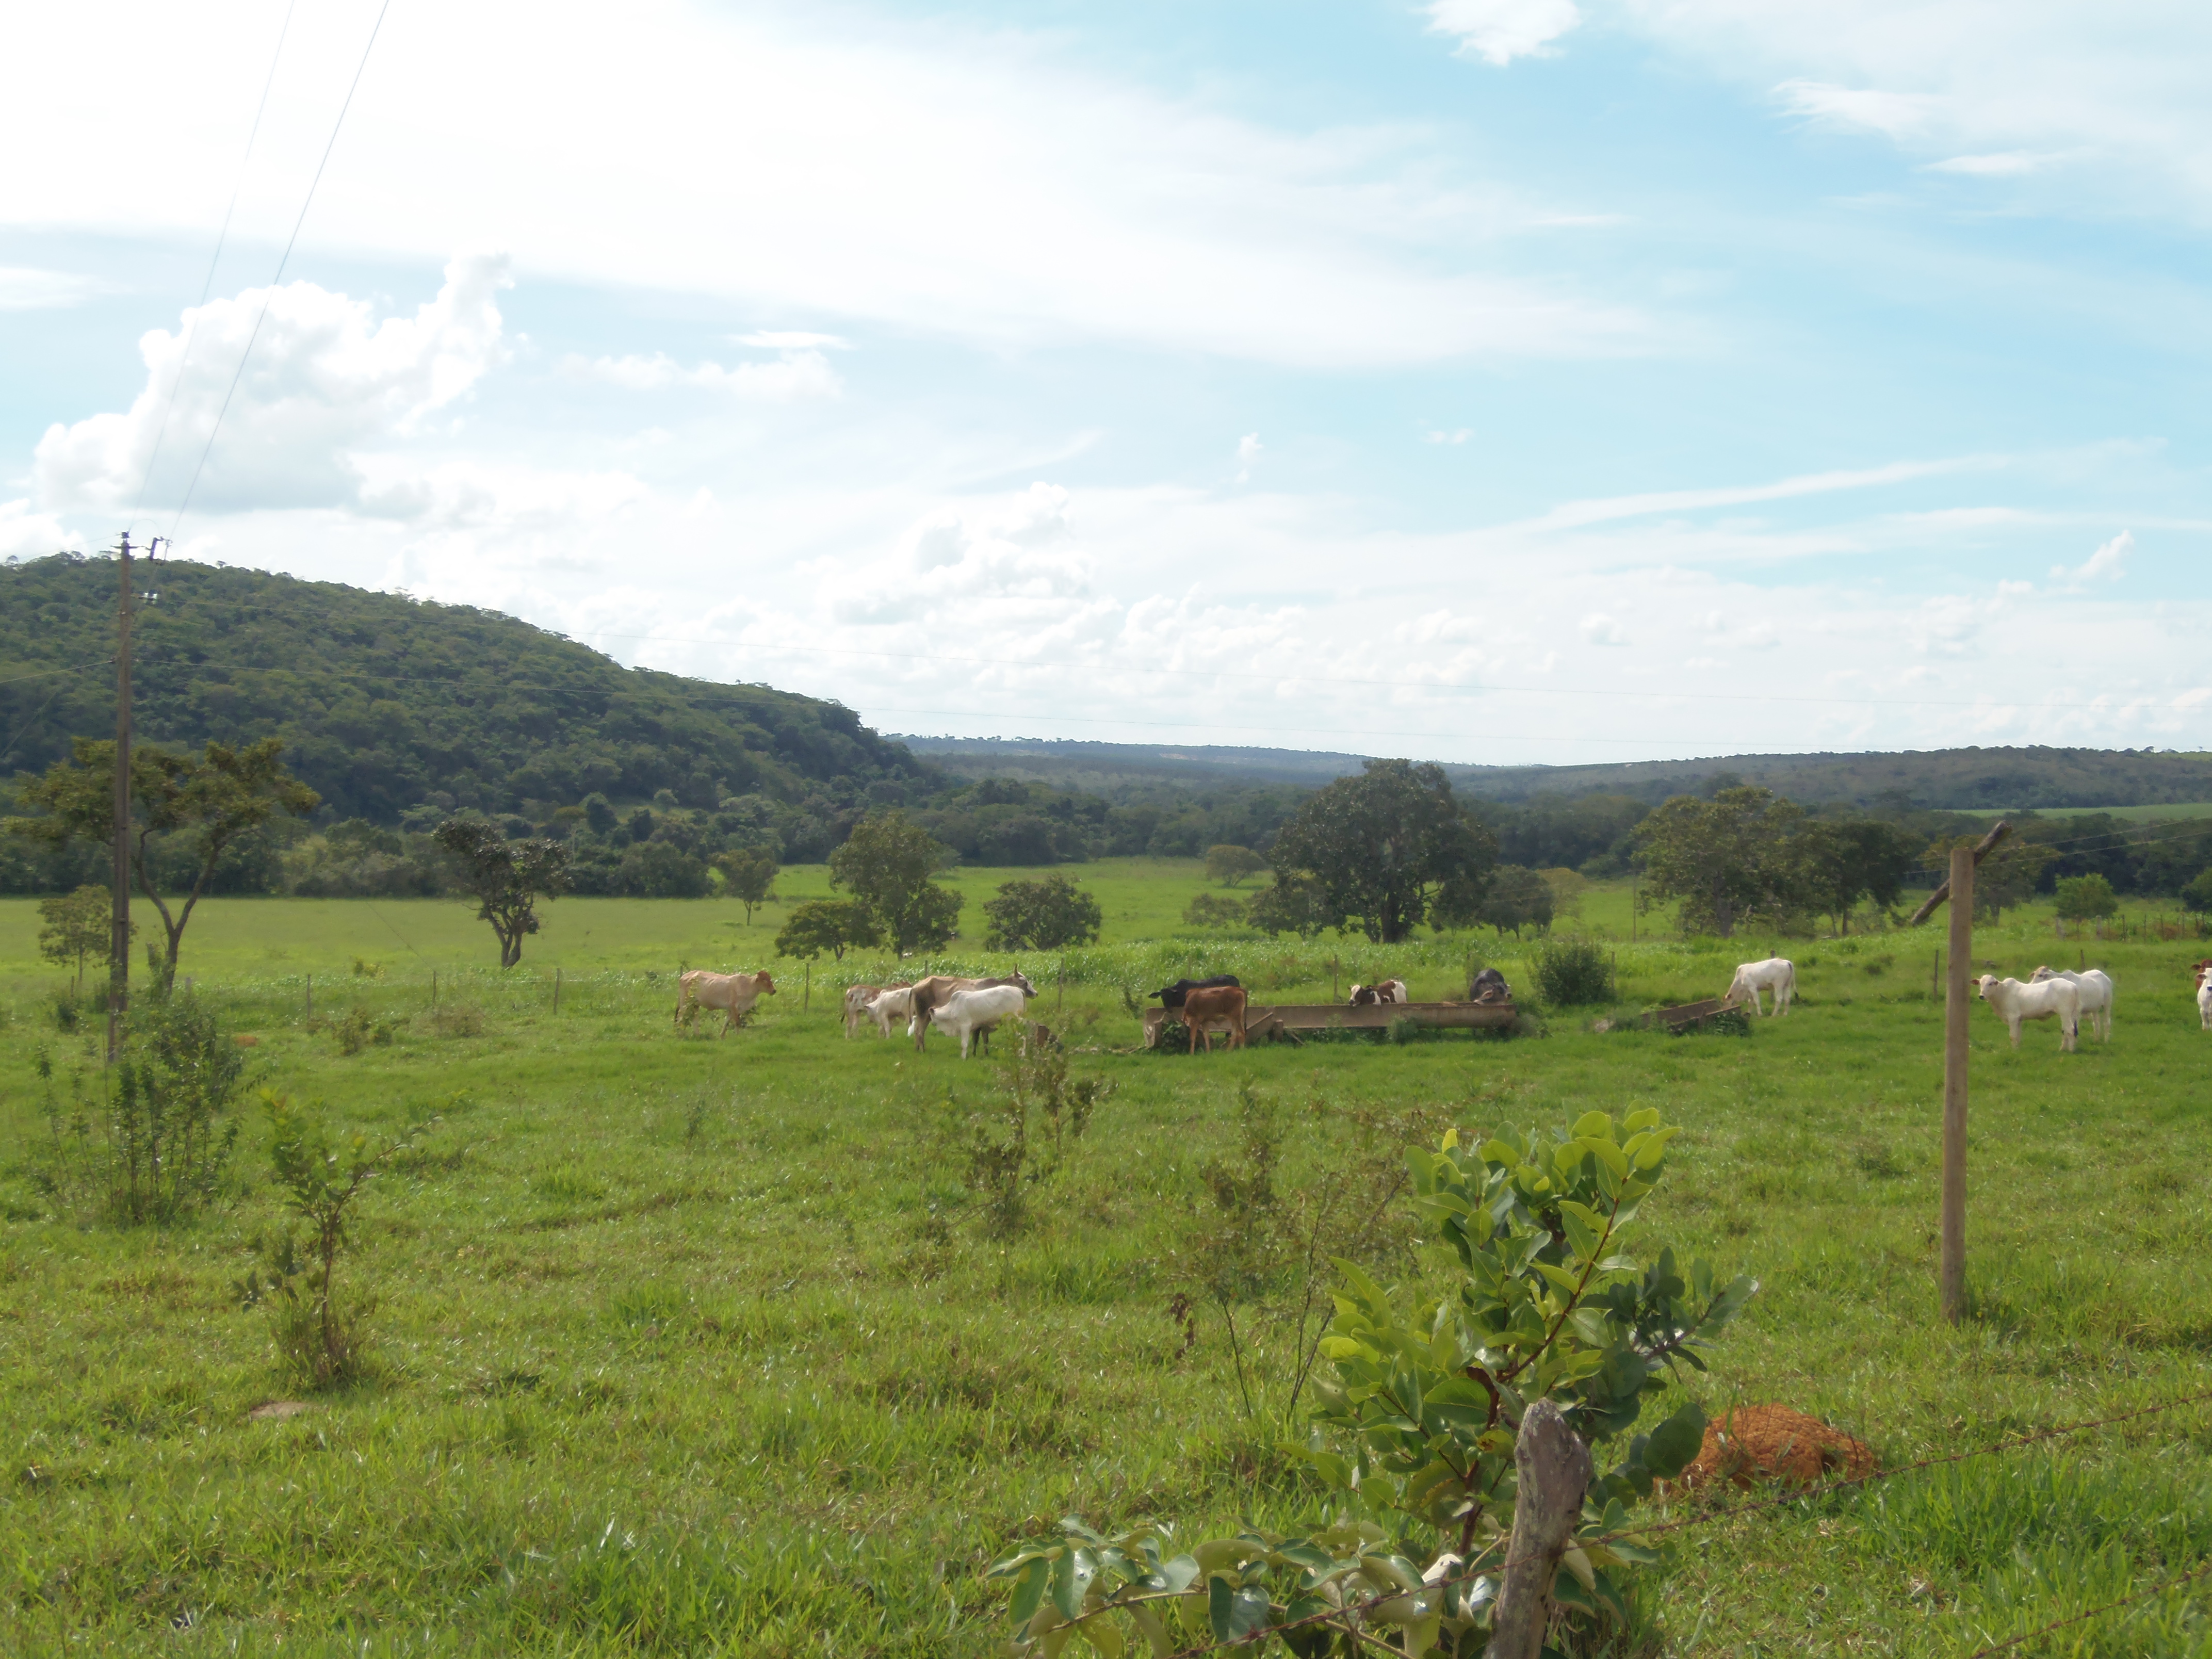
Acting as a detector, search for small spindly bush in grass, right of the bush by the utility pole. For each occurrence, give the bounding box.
[232,1093,438,1387]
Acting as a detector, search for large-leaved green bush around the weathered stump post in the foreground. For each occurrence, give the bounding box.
[989,1108,1756,1654]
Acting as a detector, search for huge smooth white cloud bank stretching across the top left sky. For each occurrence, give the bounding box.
[0,0,1657,365]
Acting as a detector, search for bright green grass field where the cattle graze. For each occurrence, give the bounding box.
[0,863,2212,1654]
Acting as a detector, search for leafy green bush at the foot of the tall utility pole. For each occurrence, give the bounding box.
[31,991,246,1226]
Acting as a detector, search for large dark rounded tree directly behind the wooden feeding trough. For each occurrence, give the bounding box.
[1274,761,1498,945]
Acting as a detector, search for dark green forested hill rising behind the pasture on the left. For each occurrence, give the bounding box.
[0,553,945,825]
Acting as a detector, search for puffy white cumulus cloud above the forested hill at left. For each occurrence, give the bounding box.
[33,254,511,511]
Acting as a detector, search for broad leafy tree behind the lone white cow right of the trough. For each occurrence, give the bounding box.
[1637,783,1805,938]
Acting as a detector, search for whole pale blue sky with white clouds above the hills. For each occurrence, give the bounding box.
[0,0,2212,763]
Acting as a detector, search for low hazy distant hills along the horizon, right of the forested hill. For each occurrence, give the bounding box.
[898,737,2212,812]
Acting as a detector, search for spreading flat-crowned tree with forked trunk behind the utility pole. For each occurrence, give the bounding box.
[7,737,323,991]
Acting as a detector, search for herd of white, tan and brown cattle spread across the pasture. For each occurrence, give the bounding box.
[677,955,2212,1060]
